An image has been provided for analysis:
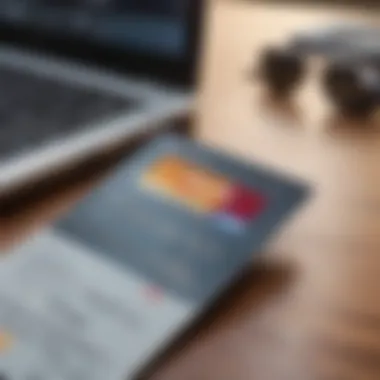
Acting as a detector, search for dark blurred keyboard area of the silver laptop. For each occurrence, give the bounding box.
[0,67,137,160]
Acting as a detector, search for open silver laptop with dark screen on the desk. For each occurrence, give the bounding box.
[0,0,204,195]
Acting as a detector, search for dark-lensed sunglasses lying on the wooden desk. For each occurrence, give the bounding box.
[258,25,380,118]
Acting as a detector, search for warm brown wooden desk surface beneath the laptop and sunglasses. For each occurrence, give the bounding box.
[3,1,380,380]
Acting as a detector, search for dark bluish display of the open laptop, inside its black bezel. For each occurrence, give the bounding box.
[0,0,190,59]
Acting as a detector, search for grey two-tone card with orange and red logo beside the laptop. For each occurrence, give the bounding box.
[0,135,308,380]
